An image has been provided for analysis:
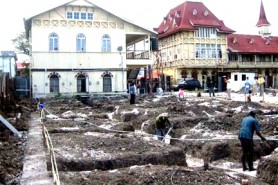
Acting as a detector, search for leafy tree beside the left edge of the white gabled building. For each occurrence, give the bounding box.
[12,32,31,55]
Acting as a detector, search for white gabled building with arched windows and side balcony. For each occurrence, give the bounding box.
[24,0,155,96]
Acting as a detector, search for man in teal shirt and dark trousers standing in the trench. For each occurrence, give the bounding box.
[238,111,266,171]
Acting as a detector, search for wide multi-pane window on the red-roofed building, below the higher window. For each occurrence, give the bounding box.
[195,44,222,58]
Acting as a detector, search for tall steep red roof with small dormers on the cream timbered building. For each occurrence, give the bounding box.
[155,1,235,38]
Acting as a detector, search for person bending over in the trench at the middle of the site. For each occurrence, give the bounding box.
[155,113,172,141]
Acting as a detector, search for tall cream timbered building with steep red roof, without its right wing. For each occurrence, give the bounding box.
[154,2,234,89]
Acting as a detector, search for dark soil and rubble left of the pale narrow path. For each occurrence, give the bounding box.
[0,98,30,184]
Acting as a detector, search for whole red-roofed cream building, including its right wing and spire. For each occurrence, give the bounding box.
[153,1,278,91]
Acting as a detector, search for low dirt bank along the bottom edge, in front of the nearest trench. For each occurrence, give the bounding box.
[60,165,267,185]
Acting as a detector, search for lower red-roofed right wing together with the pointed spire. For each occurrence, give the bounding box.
[225,2,278,88]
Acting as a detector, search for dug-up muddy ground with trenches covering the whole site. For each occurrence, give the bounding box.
[0,93,278,185]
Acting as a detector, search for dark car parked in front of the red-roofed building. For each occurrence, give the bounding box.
[172,78,202,91]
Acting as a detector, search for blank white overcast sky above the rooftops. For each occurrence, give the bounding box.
[0,0,278,51]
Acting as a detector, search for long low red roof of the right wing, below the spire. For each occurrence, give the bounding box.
[228,34,278,54]
